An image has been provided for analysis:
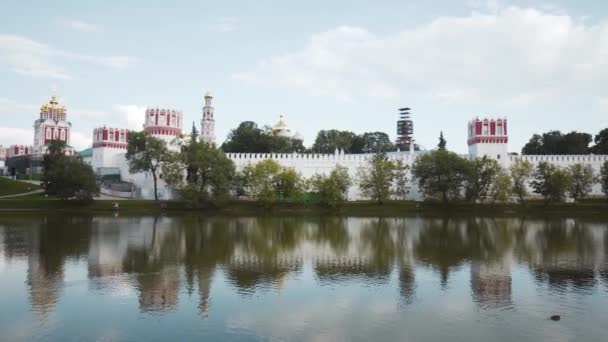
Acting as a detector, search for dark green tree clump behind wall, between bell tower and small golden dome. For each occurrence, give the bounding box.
[222,121,305,153]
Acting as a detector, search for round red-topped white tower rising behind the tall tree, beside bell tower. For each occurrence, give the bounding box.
[144,108,182,144]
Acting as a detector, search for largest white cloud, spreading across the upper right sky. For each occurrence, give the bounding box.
[233,6,608,103]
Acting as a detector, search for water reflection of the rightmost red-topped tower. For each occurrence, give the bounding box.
[471,255,512,308]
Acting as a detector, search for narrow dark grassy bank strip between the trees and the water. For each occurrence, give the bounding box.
[0,196,608,218]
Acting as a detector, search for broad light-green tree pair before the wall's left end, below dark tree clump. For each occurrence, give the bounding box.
[242,159,305,207]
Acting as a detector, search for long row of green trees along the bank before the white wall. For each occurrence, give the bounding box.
[127,129,608,208]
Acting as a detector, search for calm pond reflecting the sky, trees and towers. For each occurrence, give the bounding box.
[0,213,608,341]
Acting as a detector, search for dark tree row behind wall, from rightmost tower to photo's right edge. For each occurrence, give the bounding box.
[521,128,608,155]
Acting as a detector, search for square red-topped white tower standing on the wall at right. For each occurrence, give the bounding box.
[468,118,509,163]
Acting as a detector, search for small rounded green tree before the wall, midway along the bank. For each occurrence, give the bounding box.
[310,165,352,208]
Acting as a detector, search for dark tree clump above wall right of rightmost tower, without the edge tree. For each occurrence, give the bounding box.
[521,131,592,155]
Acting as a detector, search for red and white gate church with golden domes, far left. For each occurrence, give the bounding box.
[32,96,74,155]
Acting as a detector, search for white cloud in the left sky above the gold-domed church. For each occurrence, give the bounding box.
[0,34,137,79]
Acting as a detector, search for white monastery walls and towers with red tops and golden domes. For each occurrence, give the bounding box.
[0,93,608,200]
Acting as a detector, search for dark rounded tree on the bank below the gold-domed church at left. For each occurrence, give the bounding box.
[44,155,99,202]
